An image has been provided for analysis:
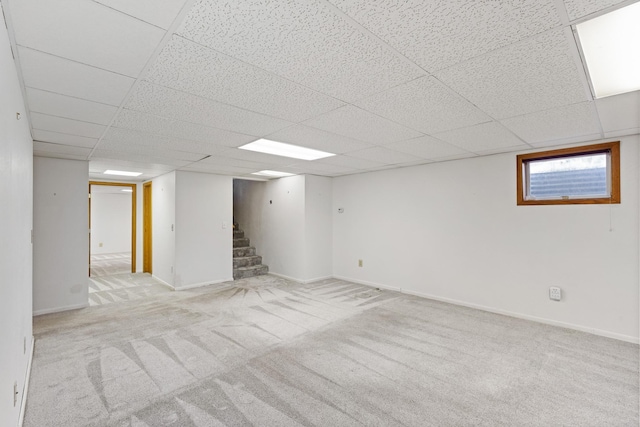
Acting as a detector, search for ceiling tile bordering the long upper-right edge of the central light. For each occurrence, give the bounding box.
[267,125,371,154]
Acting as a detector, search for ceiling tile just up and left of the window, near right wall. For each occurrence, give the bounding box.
[434,122,529,153]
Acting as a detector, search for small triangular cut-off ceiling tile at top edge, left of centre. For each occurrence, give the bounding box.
[94,0,185,29]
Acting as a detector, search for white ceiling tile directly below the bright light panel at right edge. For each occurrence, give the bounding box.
[595,90,640,133]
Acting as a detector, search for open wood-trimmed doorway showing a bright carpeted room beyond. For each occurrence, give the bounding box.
[89,181,136,277]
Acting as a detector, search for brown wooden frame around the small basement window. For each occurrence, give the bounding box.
[516,141,621,206]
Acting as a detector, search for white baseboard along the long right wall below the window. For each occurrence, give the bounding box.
[334,276,640,344]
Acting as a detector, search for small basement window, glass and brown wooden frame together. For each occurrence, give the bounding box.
[517,141,620,205]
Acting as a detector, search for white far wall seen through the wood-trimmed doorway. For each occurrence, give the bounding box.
[91,192,132,255]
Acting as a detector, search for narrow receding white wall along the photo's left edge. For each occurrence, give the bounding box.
[0,16,33,427]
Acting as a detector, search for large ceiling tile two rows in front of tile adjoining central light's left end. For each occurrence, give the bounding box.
[146,36,344,122]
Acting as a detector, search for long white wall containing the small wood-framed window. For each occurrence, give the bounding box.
[333,136,640,342]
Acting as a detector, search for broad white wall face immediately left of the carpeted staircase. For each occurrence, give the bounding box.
[173,171,233,289]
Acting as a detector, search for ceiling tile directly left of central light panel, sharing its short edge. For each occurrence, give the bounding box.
[113,109,256,147]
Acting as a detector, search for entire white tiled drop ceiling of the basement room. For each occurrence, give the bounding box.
[1,0,640,180]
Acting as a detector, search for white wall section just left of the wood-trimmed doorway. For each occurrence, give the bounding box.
[33,157,89,314]
